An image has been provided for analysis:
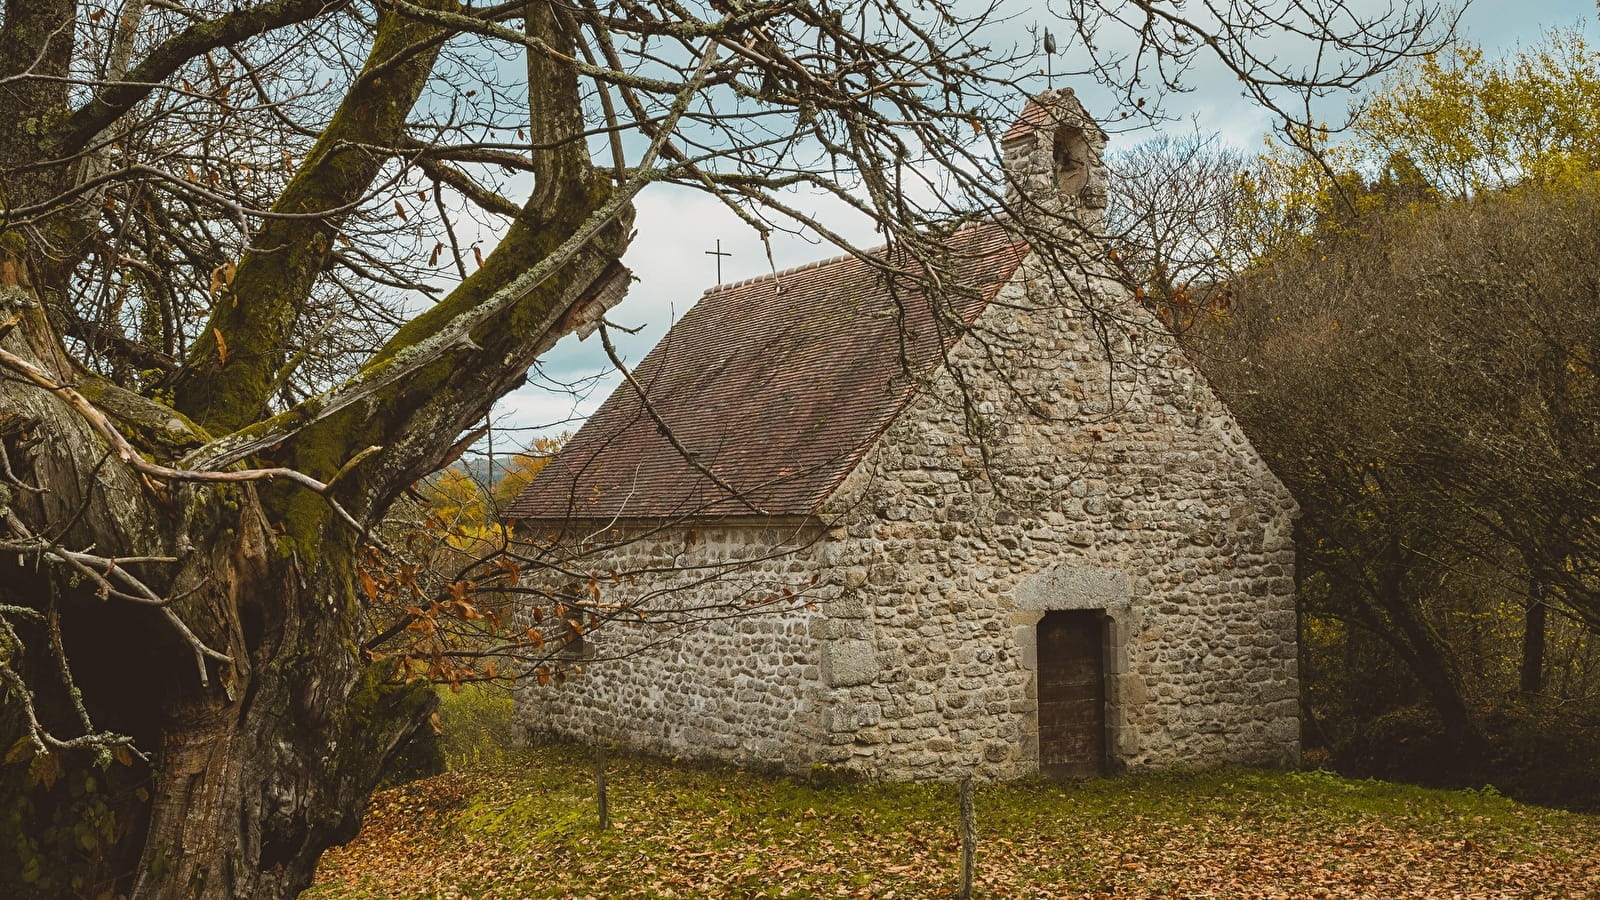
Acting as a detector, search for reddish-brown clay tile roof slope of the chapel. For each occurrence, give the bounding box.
[507,217,1026,520]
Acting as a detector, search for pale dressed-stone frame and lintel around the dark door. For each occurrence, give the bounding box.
[1011,564,1138,762]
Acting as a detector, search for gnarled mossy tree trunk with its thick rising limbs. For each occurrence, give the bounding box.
[0,0,632,900]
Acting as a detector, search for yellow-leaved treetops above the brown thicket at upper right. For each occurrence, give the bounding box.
[1232,29,1600,262]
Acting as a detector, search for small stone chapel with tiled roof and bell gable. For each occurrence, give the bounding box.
[510,90,1299,778]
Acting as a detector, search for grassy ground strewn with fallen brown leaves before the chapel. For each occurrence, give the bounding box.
[307,748,1600,900]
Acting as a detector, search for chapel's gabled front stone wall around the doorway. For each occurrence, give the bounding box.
[816,261,1299,778]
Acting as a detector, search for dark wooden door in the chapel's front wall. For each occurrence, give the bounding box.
[1038,610,1106,777]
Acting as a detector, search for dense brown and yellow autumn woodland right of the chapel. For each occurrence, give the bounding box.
[1120,30,1600,807]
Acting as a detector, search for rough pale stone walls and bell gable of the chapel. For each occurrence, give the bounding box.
[517,90,1299,778]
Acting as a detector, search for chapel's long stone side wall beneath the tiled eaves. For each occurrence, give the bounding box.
[517,524,838,769]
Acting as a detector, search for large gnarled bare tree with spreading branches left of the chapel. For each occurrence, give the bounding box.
[0,0,1442,898]
